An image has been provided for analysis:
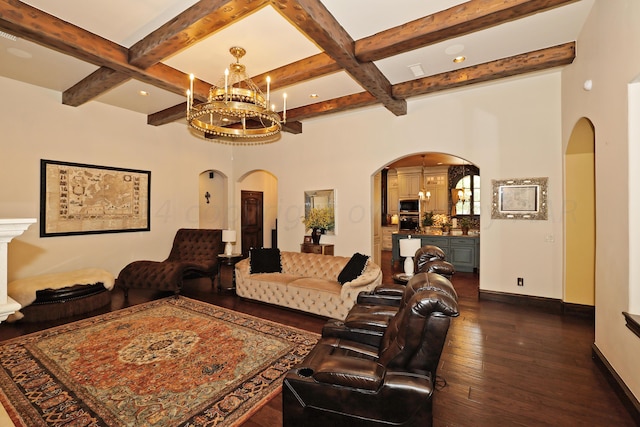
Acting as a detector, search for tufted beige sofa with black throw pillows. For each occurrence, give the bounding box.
[236,251,382,320]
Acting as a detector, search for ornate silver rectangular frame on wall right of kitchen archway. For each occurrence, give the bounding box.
[491,178,548,220]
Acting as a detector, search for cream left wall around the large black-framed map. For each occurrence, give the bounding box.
[0,78,232,281]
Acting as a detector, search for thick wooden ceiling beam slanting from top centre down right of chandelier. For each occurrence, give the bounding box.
[272,0,407,116]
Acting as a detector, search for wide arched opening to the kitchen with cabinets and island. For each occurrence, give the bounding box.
[372,152,482,290]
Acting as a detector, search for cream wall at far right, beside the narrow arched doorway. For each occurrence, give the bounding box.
[562,0,640,397]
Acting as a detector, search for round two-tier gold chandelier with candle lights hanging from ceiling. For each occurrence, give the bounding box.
[187,47,287,145]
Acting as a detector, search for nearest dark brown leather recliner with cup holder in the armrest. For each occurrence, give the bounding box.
[282,289,458,427]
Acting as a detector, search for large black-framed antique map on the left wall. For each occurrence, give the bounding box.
[40,159,151,237]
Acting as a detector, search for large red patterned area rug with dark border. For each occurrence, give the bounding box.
[0,297,318,427]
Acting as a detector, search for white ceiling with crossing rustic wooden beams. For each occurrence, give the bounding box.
[0,0,595,133]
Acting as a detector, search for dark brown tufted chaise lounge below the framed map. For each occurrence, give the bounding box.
[116,228,224,298]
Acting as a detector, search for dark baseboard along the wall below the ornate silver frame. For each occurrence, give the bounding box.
[479,289,595,320]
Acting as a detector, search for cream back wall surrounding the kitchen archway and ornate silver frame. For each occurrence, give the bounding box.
[234,72,562,298]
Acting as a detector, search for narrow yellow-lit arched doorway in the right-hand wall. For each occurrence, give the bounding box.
[563,118,596,306]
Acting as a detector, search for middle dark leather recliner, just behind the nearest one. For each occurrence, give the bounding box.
[322,273,458,346]
